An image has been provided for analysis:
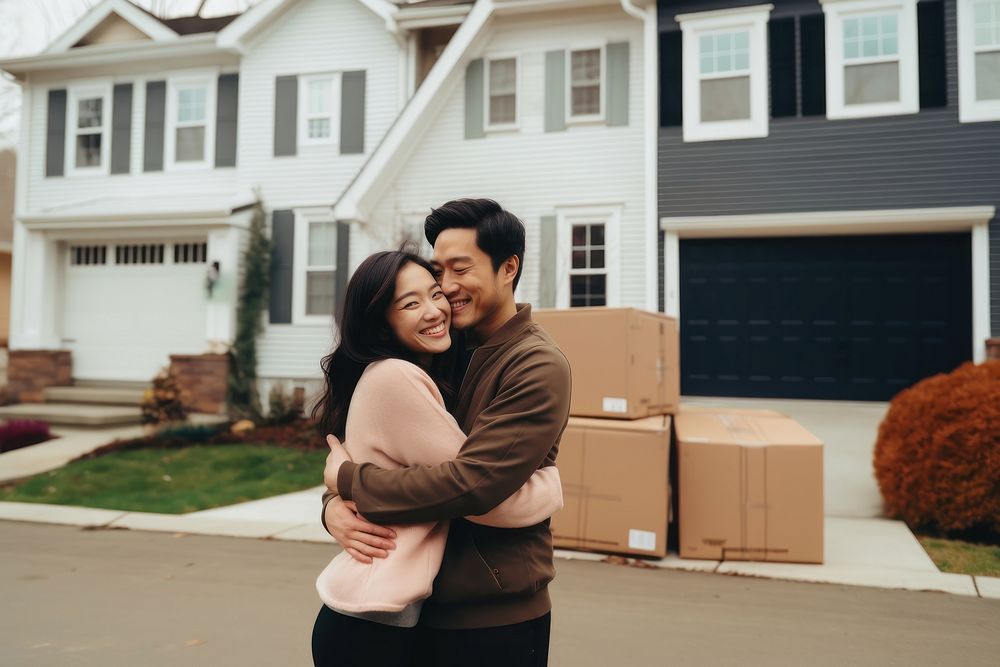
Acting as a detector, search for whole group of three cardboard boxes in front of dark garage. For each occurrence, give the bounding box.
[535,308,823,563]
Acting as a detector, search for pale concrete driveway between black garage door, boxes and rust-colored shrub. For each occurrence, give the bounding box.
[681,396,889,518]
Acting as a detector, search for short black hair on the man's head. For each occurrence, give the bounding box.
[424,199,524,290]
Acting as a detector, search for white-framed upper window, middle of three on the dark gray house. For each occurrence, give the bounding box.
[822,0,920,118]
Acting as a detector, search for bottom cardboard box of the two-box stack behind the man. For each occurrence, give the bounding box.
[551,416,670,557]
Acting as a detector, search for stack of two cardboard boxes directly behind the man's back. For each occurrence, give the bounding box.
[534,308,680,556]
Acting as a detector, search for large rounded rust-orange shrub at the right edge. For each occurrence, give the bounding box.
[875,361,1000,535]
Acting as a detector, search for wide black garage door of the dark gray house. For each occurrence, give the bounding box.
[680,234,972,401]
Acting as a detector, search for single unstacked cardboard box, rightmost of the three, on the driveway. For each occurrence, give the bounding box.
[674,410,823,563]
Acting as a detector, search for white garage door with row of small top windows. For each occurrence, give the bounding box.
[63,240,207,381]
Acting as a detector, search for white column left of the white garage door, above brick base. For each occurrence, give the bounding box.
[10,220,63,350]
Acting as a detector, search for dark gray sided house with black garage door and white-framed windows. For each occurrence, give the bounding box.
[658,0,1000,400]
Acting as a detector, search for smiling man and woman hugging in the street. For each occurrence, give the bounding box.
[312,199,570,667]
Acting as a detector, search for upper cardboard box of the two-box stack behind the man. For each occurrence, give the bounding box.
[532,308,680,419]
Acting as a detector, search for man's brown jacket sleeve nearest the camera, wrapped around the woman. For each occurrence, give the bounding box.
[337,345,570,523]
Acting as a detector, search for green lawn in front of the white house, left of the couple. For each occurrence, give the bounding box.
[0,444,326,514]
